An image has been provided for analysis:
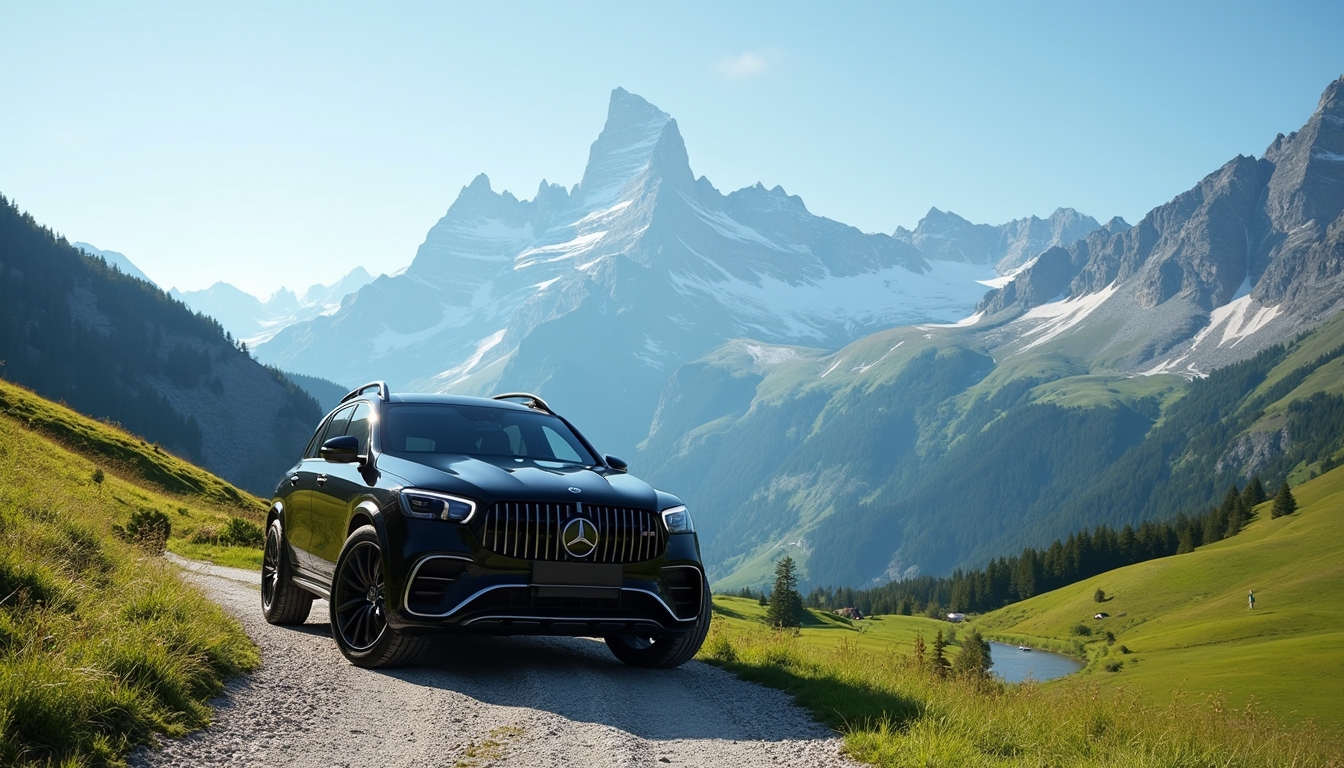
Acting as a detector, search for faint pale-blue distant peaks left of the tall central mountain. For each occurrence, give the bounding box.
[168,266,374,347]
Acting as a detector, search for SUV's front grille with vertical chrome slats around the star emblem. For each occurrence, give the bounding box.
[481,502,668,564]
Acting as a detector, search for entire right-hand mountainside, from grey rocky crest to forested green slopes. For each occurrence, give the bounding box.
[634,78,1344,588]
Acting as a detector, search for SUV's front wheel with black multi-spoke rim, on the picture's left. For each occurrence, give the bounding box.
[331,526,425,668]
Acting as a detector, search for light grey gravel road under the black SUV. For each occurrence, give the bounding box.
[130,561,857,768]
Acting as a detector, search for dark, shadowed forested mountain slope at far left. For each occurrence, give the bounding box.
[0,198,321,494]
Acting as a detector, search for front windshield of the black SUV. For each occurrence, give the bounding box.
[382,404,597,465]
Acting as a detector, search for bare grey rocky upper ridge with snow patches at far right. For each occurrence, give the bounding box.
[977,78,1344,375]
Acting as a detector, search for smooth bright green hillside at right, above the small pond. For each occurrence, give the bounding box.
[976,469,1344,729]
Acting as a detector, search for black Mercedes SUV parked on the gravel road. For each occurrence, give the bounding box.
[261,382,711,667]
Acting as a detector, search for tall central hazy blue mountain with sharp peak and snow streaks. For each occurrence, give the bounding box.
[257,89,1010,451]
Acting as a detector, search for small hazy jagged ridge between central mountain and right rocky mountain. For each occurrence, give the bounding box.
[892,208,1101,274]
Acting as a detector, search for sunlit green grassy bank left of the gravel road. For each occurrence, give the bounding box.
[0,383,263,767]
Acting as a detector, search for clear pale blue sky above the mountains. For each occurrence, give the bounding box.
[0,0,1344,293]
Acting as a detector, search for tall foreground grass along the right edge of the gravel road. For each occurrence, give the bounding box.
[700,617,1344,768]
